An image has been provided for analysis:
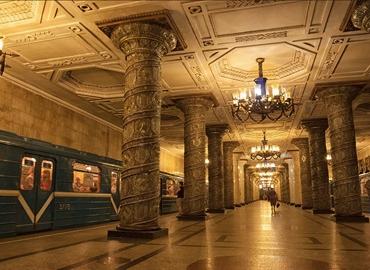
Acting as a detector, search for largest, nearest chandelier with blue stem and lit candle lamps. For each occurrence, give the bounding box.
[232,58,294,123]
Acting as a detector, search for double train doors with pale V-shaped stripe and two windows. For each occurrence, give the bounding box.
[17,155,55,232]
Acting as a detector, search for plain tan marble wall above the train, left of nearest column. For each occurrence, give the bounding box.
[0,78,121,159]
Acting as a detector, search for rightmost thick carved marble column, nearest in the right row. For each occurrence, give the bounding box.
[318,86,369,222]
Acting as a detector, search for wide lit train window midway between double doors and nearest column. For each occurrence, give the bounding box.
[72,162,101,192]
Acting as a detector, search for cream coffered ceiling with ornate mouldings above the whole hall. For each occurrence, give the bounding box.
[0,0,370,159]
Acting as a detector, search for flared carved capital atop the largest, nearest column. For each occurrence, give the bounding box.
[111,22,177,57]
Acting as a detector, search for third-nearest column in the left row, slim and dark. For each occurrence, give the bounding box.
[206,125,229,213]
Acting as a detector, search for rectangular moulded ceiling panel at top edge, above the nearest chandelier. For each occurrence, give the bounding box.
[183,0,332,47]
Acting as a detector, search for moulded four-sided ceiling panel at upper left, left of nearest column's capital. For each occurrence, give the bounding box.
[2,23,118,72]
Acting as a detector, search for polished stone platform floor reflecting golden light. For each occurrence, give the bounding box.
[0,201,370,270]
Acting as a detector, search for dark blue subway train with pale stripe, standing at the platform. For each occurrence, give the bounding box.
[0,131,182,237]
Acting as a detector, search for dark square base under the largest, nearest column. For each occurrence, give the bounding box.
[108,227,168,239]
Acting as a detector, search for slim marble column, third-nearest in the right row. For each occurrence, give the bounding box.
[292,138,312,209]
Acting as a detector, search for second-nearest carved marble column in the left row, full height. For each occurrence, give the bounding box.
[175,96,213,220]
